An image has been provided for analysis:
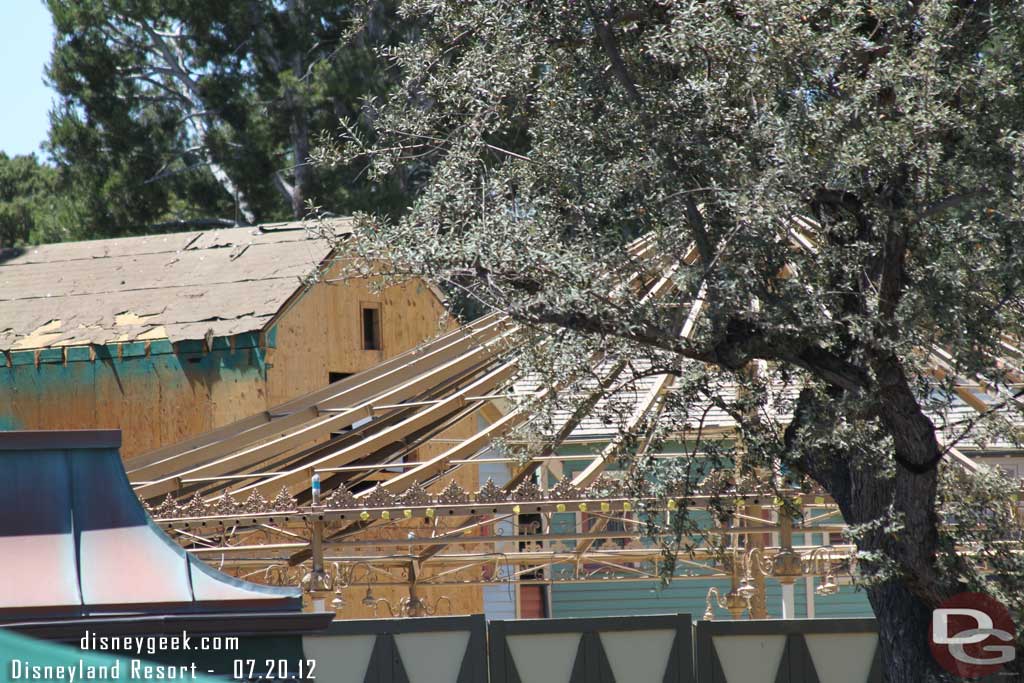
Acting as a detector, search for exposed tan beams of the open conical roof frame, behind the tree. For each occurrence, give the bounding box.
[128,220,1024,593]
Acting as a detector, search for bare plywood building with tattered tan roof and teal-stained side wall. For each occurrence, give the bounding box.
[0,220,451,458]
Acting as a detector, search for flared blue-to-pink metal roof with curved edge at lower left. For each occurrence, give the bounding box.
[0,430,302,621]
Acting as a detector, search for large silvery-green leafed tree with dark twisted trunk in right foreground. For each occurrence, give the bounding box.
[318,0,1024,681]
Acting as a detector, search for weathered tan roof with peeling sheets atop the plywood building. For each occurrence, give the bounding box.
[0,219,351,350]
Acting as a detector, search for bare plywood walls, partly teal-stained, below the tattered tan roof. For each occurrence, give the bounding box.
[0,272,447,458]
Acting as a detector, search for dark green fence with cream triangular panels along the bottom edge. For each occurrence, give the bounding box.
[303,614,883,683]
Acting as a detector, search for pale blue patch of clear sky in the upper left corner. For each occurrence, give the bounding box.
[0,0,53,156]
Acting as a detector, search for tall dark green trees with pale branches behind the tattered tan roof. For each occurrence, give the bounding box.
[47,0,407,236]
